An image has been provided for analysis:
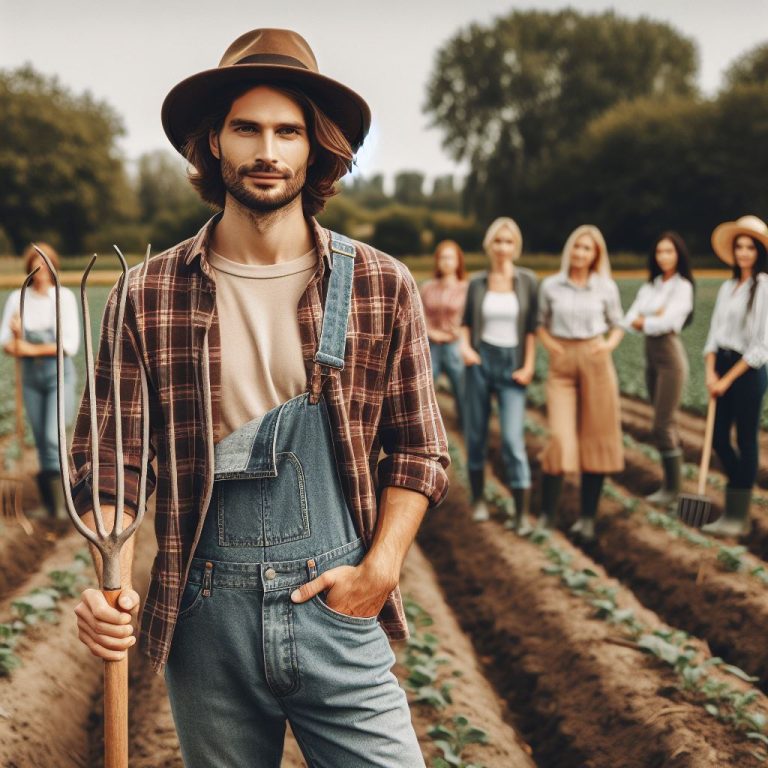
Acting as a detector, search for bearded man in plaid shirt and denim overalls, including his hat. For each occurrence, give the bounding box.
[72,29,448,768]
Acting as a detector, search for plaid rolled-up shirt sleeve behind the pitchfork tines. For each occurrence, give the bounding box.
[69,280,155,515]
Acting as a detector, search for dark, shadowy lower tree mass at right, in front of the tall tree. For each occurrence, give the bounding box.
[519,85,768,254]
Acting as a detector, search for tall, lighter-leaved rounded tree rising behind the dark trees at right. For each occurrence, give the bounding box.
[425,10,697,218]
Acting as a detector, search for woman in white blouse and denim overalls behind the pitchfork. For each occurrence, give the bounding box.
[0,243,80,518]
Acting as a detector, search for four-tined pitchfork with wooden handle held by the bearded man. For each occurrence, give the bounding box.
[25,245,149,768]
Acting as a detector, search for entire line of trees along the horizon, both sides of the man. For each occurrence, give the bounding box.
[0,10,768,255]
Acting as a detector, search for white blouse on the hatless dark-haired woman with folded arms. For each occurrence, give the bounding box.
[621,273,693,336]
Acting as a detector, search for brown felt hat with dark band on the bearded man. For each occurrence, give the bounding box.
[161,29,371,152]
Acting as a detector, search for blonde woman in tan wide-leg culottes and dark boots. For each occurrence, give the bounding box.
[538,224,624,540]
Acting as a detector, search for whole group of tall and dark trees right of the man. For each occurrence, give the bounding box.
[424,10,768,251]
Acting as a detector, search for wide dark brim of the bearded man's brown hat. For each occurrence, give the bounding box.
[161,64,371,152]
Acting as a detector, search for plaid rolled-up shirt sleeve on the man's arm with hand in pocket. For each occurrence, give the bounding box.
[378,274,450,507]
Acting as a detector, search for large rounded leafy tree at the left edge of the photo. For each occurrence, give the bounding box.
[0,66,134,253]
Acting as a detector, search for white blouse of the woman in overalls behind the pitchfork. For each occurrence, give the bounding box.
[0,286,80,357]
